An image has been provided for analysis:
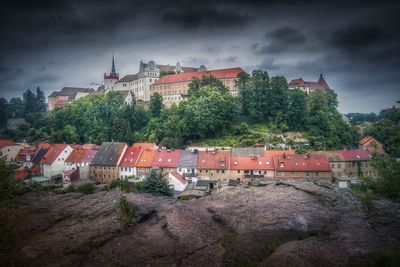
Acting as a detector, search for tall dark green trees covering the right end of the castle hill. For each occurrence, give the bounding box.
[238,70,358,149]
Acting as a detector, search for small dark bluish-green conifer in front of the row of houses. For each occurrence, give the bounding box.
[143,169,173,196]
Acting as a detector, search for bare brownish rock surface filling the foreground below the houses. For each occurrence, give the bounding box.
[3,181,400,266]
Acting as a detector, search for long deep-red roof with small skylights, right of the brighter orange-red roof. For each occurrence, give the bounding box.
[274,154,331,172]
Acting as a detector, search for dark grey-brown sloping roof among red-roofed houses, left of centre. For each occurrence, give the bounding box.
[91,142,126,167]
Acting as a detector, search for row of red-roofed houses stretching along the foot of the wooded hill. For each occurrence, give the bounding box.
[0,137,384,191]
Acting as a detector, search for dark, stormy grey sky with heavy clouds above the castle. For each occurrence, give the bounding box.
[0,0,400,113]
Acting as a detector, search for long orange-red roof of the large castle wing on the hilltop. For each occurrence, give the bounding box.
[154,68,243,85]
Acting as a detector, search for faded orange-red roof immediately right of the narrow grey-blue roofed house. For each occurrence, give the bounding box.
[197,150,231,170]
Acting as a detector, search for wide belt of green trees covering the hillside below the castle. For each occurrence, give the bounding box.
[0,70,357,149]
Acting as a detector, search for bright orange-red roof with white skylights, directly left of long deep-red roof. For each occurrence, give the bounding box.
[231,156,274,170]
